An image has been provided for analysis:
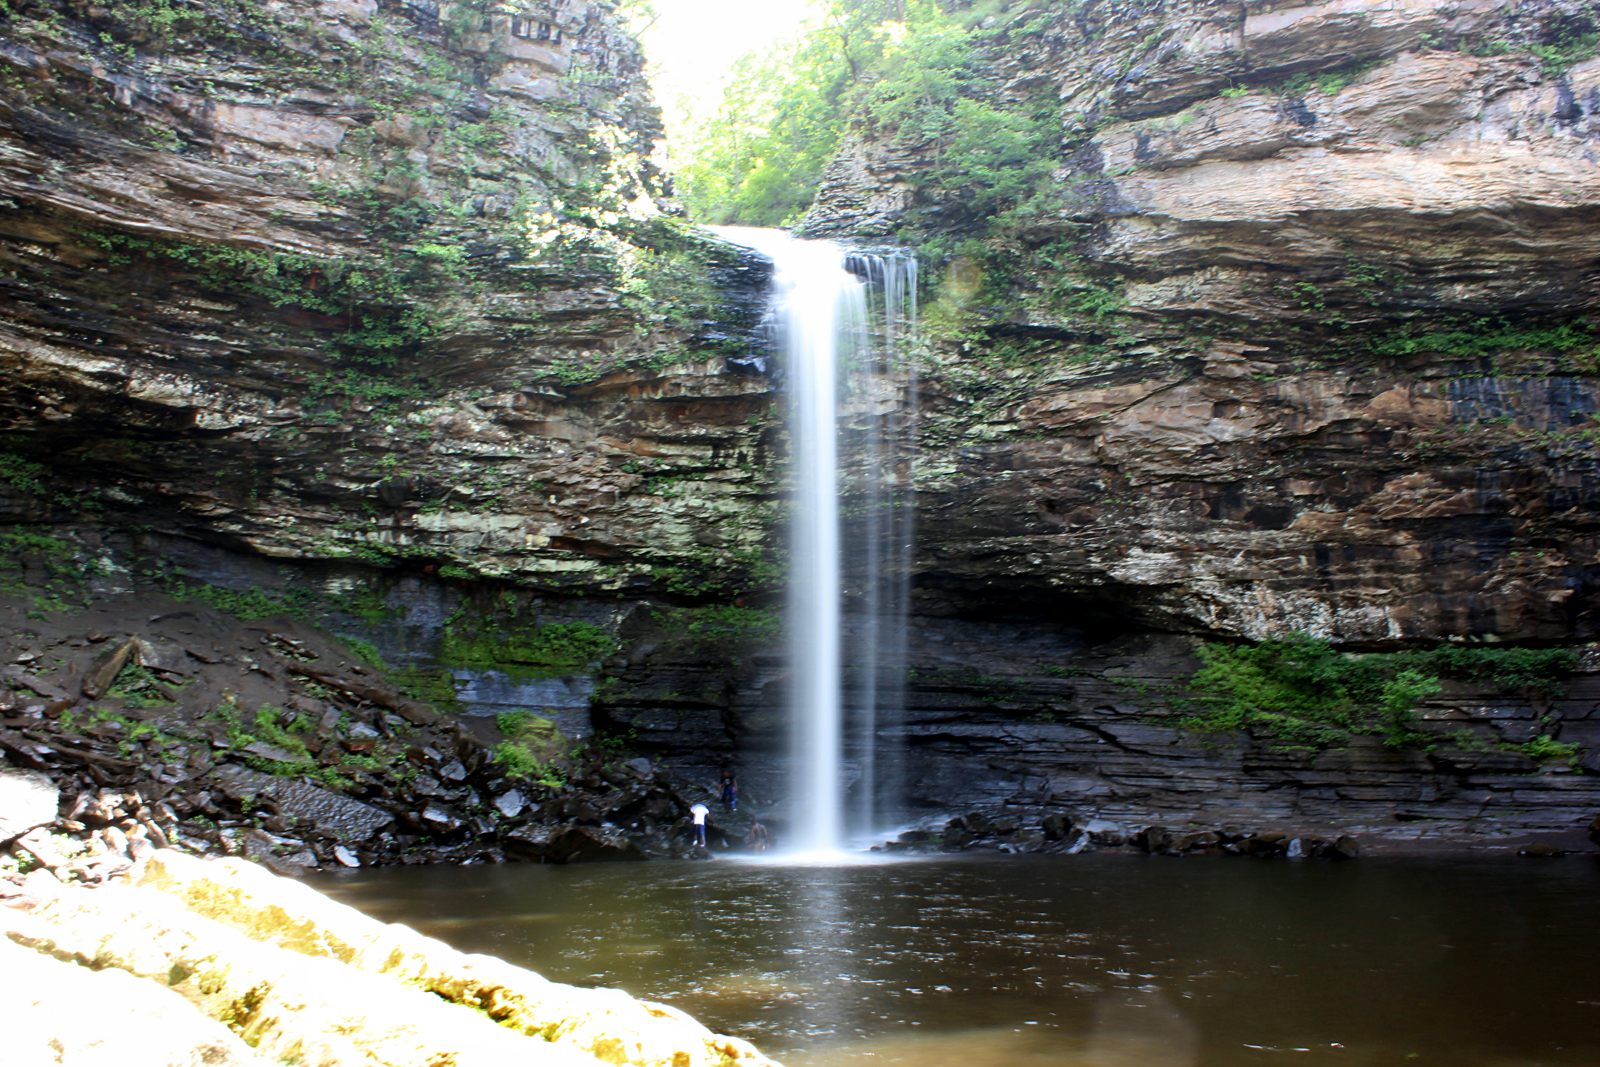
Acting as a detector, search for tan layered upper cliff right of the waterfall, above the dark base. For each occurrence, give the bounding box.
[808,2,1600,641]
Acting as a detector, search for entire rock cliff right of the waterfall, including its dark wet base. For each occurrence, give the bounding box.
[806,0,1600,838]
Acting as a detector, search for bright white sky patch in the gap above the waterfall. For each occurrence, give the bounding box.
[643,0,813,156]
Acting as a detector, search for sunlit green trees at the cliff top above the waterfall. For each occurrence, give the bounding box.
[682,0,1059,226]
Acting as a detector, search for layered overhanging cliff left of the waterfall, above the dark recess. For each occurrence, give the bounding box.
[0,0,771,592]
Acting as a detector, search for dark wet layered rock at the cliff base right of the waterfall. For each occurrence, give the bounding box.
[893,621,1600,851]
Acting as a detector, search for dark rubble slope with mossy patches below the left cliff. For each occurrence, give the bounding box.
[0,576,726,883]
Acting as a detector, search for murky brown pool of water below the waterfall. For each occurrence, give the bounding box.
[308,854,1600,1067]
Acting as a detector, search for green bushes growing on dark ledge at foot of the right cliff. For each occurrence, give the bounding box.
[1182,633,1578,758]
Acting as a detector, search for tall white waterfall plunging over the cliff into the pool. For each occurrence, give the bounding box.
[717,227,917,854]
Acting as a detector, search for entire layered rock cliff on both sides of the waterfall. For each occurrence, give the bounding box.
[0,0,1600,840]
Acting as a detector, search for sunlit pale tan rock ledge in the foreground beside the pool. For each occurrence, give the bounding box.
[0,849,774,1067]
